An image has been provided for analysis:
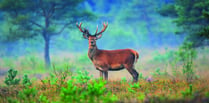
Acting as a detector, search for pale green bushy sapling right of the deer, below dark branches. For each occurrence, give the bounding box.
[152,42,197,82]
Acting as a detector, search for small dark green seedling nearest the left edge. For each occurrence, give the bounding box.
[4,69,20,86]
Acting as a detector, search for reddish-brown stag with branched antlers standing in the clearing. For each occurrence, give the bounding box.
[76,23,139,82]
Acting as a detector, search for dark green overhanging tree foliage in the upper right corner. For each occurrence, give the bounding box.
[159,0,209,47]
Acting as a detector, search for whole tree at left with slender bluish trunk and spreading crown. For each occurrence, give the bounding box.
[0,0,93,67]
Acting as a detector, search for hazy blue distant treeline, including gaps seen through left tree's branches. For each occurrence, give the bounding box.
[0,0,207,56]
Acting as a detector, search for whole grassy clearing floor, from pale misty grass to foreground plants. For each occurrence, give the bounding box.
[0,48,209,103]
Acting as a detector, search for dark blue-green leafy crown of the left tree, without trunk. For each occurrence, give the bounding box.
[0,0,91,41]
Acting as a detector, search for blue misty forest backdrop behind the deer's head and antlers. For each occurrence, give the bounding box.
[0,0,184,57]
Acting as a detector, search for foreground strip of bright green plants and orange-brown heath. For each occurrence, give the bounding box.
[0,66,208,103]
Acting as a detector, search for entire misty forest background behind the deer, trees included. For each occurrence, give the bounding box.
[0,0,209,83]
